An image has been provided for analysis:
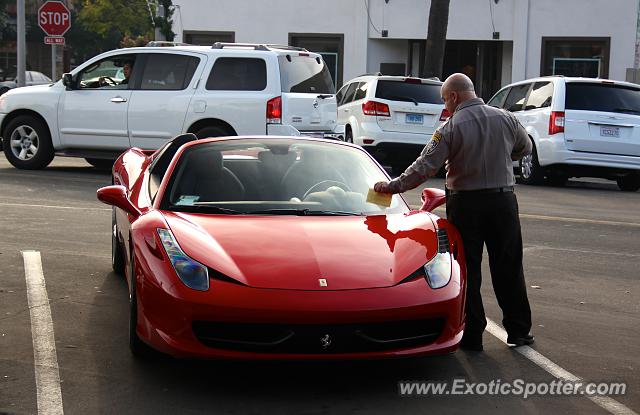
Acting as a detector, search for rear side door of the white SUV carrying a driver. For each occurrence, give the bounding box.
[128,52,207,150]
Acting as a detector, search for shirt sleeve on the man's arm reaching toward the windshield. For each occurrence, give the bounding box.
[389,122,451,193]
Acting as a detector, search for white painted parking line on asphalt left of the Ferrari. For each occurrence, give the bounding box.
[22,251,64,415]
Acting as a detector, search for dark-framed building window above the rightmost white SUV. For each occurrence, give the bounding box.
[540,37,611,78]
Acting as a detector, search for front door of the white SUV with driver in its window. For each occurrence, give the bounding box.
[58,54,136,151]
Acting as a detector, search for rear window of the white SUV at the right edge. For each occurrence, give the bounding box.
[565,82,640,114]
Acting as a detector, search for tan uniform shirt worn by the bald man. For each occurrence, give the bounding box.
[389,98,532,193]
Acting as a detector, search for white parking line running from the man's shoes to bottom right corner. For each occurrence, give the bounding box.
[487,319,638,415]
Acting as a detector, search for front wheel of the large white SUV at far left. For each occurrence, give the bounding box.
[2,115,54,170]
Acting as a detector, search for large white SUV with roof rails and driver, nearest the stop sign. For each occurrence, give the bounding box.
[0,43,340,169]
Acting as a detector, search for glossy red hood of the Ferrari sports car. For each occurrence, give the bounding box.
[164,212,438,290]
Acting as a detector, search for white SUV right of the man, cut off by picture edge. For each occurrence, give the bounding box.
[488,76,640,191]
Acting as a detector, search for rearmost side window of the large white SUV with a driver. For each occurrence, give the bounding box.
[206,58,267,91]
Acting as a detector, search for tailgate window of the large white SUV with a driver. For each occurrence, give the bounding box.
[278,55,335,94]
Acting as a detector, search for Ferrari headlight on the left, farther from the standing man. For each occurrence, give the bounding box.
[158,228,209,291]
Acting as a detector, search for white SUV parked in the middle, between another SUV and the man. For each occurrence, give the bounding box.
[336,75,449,173]
